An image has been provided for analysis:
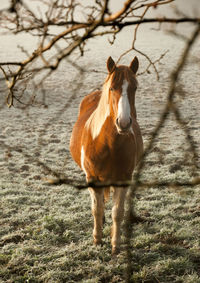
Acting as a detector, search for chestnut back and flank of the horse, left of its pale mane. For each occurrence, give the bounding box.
[70,90,101,167]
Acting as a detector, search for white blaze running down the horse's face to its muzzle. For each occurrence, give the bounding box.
[117,80,131,128]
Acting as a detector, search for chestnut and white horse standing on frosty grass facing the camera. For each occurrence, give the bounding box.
[70,57,143,254]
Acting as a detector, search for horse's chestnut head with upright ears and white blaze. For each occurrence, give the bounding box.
[107,57,139,134]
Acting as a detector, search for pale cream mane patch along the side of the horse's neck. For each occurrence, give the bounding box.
[86,83,110,140]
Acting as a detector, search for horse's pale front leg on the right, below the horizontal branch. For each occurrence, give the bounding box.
[111,187,127,254]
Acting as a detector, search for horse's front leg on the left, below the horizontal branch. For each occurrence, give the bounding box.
[89,188,104,245]
